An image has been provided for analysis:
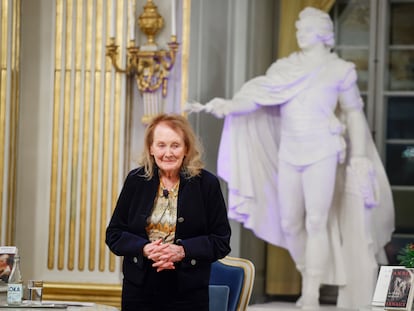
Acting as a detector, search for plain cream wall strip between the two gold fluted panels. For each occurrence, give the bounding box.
[16,0,58,279]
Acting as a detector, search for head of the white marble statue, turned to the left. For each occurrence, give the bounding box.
[296,7,335,47]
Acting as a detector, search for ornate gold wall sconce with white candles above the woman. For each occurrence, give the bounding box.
[106,0,179,124]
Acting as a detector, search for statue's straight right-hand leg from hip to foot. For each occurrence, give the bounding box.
[302,156,337,309]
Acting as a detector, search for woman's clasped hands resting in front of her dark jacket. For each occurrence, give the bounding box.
[143,239,185,272]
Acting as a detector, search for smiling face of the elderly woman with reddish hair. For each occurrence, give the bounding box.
[150,122,187,175]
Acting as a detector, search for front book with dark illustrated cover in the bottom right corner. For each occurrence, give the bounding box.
[384,267,414,310]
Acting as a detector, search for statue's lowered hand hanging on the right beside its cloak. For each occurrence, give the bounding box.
[349,156,378,208]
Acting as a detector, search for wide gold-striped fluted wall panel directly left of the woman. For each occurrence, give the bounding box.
[48,0,126,272]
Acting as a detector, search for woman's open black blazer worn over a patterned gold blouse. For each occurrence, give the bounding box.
[106,168,231,290]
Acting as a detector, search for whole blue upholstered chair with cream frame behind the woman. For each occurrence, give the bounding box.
[209,256,255,311]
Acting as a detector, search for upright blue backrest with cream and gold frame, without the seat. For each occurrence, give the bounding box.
[210,256,255,311]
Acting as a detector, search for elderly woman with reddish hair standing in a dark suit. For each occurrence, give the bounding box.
[106,114,231,311]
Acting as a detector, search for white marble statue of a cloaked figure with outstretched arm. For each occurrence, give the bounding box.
[187,7,394,309]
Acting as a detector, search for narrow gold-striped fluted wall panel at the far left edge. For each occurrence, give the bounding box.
[0,0,20,249]
